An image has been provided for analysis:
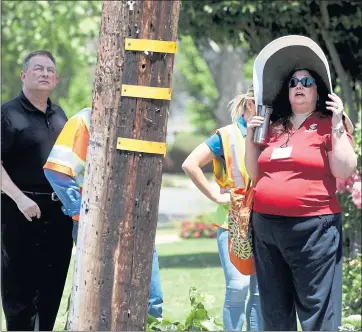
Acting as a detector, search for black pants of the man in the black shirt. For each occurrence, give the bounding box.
[1,194,73,331]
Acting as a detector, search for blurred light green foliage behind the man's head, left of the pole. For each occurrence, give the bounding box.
[1,1,101,114]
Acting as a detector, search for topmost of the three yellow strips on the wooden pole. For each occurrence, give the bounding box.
[125,38,177,54]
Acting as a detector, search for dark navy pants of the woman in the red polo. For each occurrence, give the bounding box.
[252,212,342,331]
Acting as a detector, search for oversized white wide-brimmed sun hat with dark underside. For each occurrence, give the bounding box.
[253,35,354,133]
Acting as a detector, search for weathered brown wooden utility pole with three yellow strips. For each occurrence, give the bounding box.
[68,0,180,331]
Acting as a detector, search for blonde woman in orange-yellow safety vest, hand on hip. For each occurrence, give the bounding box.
[182,87,263,331]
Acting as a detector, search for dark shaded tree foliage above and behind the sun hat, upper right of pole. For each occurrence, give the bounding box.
[180,0,362,121]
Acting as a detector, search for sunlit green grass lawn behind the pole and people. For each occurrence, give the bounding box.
[1,237,225,331]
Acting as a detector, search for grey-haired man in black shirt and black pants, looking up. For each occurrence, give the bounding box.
[1,51,73,331]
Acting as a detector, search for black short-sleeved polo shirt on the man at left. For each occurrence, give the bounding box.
[1,91,67,192]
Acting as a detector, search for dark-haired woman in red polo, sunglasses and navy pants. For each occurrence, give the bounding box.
[246,70,357,331]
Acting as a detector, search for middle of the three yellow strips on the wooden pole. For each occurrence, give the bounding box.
[121,84,172,100]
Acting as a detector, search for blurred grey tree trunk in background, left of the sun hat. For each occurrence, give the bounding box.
[197,44,248,128]
